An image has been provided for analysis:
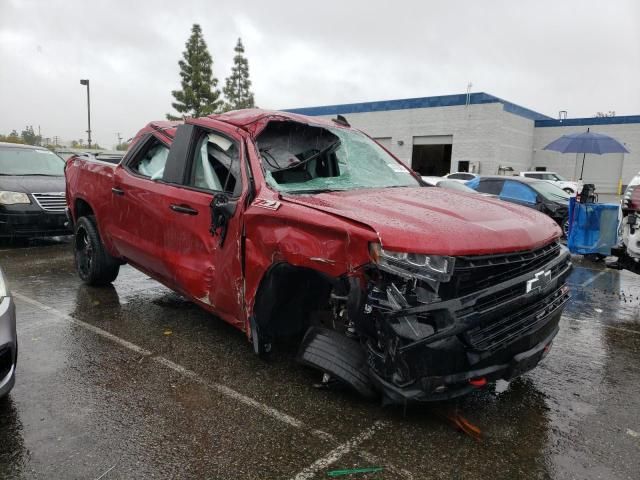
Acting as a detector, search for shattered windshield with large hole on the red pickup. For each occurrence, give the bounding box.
[257,121,419,193]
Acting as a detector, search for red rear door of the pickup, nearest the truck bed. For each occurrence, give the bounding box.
[107,134,169,281]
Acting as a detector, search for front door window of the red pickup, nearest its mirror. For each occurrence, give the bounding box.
[190,133,240,195]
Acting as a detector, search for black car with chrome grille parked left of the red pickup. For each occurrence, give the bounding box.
[0,143,71,238]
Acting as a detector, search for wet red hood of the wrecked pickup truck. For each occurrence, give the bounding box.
[283,187,561,256]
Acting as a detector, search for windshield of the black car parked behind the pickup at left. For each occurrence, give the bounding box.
[0,147,64,177]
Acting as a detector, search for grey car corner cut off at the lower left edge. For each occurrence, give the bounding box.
[0,270,18,398]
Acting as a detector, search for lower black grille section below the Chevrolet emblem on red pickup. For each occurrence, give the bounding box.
[464,286,569,351]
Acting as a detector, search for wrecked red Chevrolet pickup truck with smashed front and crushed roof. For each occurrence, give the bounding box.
[66,110,571,403]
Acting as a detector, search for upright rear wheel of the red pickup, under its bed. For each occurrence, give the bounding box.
[73,216,120,286]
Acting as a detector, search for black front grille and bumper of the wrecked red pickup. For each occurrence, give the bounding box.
[366,244,572,403]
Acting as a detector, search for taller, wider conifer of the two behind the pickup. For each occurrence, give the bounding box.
[167,23,223,120]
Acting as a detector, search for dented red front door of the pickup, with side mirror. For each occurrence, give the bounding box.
[160,121,247,328]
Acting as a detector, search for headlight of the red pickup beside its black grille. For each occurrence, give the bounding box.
[369,243,455,282]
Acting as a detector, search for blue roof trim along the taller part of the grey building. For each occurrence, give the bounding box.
[285,92,551,120]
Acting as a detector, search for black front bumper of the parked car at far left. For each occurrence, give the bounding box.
[0,211,71,238]
